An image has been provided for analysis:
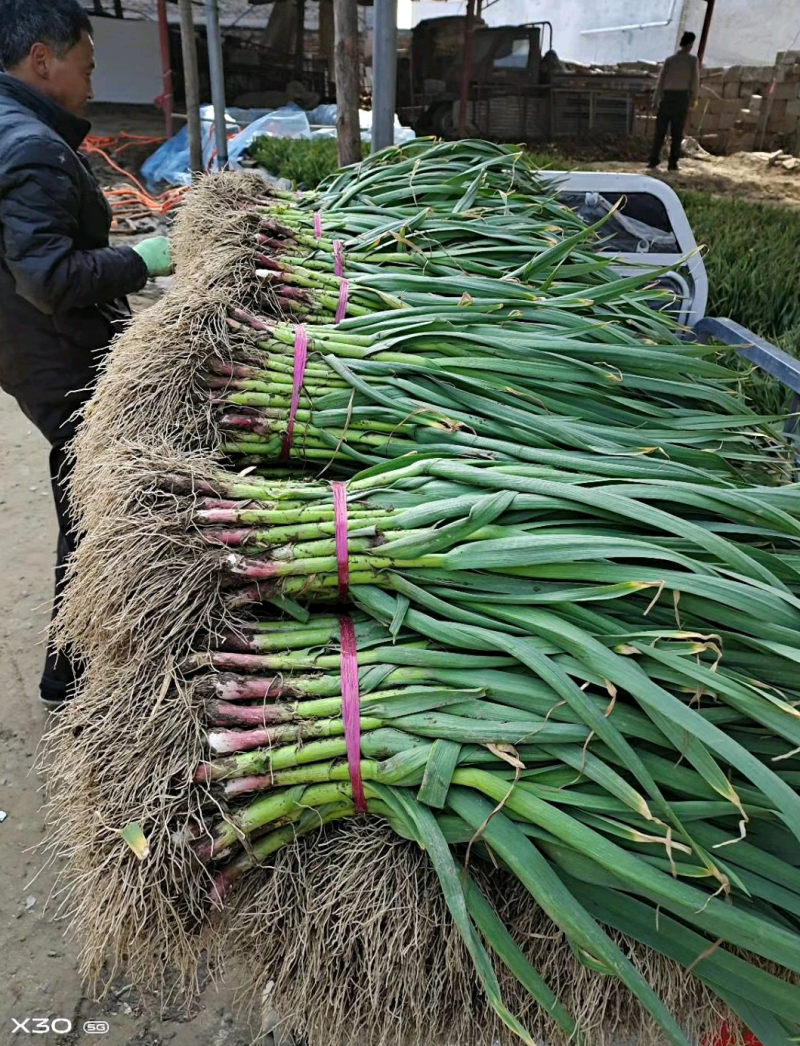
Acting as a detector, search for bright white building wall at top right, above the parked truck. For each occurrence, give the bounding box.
[398,0,800,67]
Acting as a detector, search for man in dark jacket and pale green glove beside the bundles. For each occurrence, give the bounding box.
[0,0,170,708]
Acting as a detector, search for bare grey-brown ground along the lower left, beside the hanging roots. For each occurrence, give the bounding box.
[0,274,256,1046]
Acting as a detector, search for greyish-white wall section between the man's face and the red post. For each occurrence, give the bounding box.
[92,16,164,105]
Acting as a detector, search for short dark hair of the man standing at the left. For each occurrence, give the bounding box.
[0,0,92,69]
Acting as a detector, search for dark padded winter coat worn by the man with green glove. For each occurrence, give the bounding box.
[0,73,147,442]
